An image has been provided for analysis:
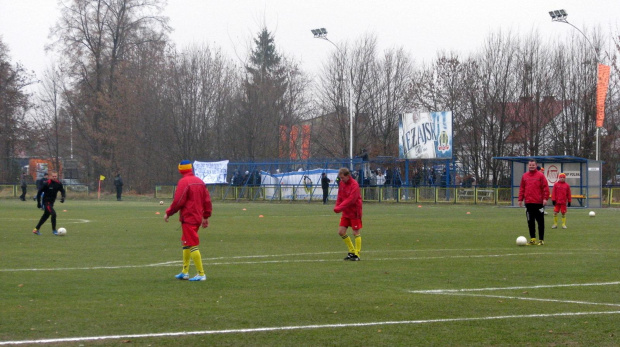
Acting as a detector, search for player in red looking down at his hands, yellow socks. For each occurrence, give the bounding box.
[334,168,362,261]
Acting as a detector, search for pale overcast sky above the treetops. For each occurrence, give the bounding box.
[0,0,620,81]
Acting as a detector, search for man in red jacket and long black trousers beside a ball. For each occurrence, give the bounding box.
[519,159,549,246]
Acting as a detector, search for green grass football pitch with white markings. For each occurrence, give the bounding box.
[0,199,620,346]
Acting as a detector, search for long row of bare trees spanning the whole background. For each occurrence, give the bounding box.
[0,0,620,192]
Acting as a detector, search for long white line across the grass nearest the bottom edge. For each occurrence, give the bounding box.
[0,311,620,345]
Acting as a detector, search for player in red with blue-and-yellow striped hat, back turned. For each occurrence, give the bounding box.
[164,160,213,281]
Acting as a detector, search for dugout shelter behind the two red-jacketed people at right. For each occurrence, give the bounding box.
[493,156,602,208]
